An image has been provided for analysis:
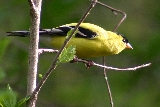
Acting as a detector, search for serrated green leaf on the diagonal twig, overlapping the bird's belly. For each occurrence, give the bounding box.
[57,45,76,64]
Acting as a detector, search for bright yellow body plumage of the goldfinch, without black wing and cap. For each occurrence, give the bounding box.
[51,23,130,58]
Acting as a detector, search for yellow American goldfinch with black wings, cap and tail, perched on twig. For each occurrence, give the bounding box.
[7,23,133,58]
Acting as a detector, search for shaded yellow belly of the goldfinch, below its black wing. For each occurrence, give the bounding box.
[52,37,112,58]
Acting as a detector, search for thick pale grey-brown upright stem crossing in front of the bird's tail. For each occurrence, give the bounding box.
[27,0,42,107]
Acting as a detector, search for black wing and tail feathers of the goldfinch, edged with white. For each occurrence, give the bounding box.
[7,26,97,39]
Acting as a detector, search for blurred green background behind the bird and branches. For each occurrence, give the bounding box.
[0,0,160,107]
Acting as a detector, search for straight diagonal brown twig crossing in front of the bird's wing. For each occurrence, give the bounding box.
[32,0,97,100]
